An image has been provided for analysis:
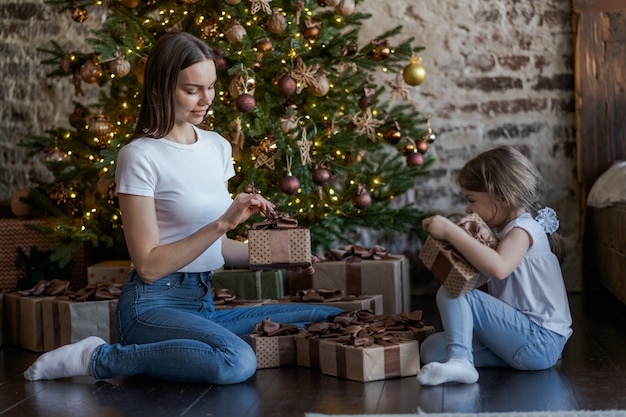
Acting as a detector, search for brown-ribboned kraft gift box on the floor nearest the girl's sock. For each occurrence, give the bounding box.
[319,340,420,382]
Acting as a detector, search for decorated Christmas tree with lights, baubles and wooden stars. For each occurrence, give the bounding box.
[27,0,435,261]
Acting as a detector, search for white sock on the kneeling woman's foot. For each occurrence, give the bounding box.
[24,336,106,381]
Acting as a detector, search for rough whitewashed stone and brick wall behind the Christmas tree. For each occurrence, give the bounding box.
[0,0,582,291]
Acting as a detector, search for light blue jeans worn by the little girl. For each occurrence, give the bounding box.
[420,287,566,370]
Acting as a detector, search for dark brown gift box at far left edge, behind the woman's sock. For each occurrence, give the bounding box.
[4,293,55,352]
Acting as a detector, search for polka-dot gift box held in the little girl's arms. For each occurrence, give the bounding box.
[419,213,498,297]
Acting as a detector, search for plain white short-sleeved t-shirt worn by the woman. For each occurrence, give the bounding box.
[115,128,235,272]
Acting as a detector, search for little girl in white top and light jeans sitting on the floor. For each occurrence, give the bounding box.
[417,146,572,385]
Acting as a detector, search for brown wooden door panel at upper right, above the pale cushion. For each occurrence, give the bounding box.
[573,0,626,196]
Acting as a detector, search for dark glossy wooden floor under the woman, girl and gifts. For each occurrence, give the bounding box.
[0,291,626,417]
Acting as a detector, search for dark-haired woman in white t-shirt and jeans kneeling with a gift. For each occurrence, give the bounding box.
[24,32,341,384]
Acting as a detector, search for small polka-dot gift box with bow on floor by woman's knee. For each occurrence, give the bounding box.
[243,318,301,369]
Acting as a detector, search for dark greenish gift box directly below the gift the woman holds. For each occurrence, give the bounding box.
[211,269,287,300]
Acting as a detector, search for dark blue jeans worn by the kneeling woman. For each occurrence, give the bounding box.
[91,271,342,384]
